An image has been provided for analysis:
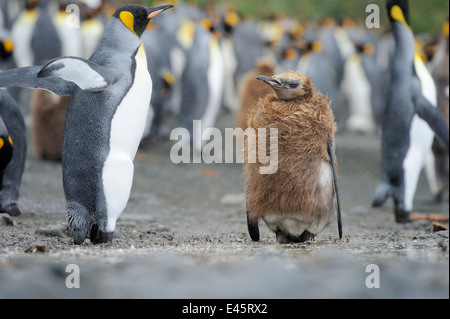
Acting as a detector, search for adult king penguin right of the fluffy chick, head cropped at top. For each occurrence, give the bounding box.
[372,0,449,223]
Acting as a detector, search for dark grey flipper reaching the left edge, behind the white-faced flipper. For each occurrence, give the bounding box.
[0,66,76,96]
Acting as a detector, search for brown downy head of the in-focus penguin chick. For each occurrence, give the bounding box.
[256,71,313,101]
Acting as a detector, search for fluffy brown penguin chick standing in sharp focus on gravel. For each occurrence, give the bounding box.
[244,71,342,243]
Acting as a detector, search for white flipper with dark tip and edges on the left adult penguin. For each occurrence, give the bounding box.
[37,57,117,92]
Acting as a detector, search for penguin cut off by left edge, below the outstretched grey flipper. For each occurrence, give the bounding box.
[0,89,27,216]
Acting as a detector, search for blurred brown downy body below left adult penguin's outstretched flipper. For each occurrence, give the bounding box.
[30,90,70,161]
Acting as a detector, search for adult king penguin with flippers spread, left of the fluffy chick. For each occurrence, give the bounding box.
[0,5,173,244]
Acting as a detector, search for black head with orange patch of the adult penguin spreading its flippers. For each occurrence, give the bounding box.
[113,4,173,37]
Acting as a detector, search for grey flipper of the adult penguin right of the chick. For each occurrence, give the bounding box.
[411,78,449,154]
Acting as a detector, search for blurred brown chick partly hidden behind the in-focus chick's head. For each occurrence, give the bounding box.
[236,59,275,130]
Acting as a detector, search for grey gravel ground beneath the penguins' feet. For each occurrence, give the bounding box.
[0,116,449,300]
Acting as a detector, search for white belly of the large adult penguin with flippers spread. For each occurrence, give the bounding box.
[103,46,152,232]
